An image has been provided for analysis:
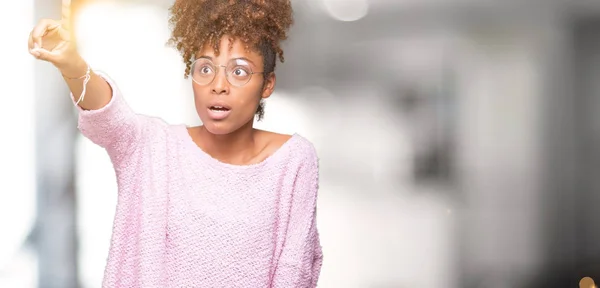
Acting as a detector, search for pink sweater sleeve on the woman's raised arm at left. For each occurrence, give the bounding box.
[71,72,142,161]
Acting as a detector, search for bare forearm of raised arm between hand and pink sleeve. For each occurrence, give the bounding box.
[60,57,112,110]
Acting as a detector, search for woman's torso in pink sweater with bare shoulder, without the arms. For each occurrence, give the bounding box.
[101,120,316,287]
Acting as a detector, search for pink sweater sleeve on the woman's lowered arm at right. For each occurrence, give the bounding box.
[272,147,323,288]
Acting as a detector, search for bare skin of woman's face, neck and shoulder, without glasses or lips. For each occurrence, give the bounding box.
[188,36,291,165]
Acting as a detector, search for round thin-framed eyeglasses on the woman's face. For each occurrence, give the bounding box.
[192,58,264,87]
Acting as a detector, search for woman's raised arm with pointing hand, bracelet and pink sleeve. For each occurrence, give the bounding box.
[29,0,142,160]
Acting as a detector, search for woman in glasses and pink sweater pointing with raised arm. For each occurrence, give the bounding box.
[29,0,322,288]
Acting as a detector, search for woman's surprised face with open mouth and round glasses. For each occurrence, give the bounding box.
[191,37,275,135]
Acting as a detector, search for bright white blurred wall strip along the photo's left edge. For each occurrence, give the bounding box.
[0,0,37,287]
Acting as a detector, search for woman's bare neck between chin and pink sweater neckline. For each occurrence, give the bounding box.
[199,121,256,164]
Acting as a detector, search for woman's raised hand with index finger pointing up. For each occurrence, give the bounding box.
[29,0,85,73]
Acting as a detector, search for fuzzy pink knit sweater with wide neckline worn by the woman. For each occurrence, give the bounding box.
[71,73,323,288]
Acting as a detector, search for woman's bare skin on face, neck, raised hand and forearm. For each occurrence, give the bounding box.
[28,0,291,165]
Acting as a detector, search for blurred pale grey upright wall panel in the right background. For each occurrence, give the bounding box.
[457,25,550,287]
